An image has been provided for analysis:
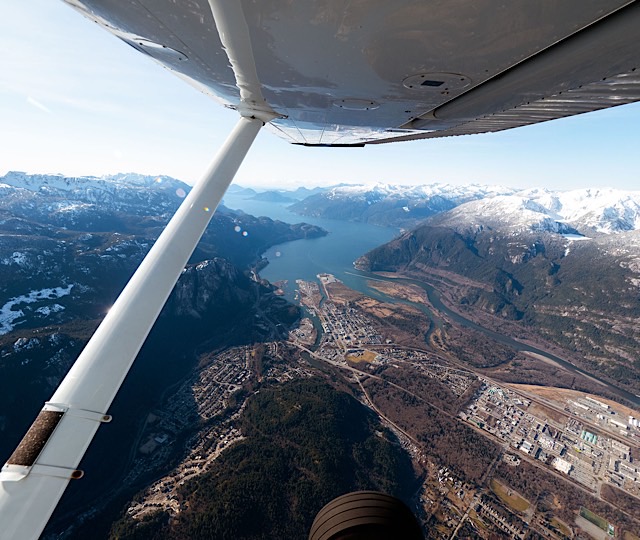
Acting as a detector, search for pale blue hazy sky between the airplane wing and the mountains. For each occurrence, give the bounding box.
[0,0,640,190]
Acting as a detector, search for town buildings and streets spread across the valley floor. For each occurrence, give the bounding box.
[121,274,640,540]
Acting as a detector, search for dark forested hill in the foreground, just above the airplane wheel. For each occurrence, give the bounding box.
[111,379,419,540]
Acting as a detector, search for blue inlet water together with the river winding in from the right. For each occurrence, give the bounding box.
[225,196,640,407]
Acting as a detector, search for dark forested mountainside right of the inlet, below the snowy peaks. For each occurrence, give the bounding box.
[359,225,640,394]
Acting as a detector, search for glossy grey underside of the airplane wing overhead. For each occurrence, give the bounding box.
[61,0,640,146]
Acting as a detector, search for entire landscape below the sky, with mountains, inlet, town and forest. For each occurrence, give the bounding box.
[0,173,640,539]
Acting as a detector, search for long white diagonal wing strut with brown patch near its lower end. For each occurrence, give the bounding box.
[0,117,263,540]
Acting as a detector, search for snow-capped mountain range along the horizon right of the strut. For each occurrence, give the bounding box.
[233,183,640,235]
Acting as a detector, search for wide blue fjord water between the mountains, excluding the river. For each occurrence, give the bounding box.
[224,194,400,300]
